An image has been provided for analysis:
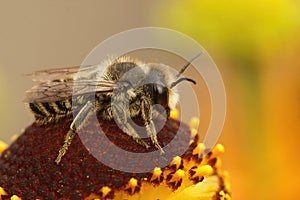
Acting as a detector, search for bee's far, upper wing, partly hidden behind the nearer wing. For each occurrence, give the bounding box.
[27,65,104,82]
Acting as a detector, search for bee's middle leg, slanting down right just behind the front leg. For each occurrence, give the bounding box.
[112,103,149,148]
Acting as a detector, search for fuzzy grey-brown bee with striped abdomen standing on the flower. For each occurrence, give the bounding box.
[25,52,202,164]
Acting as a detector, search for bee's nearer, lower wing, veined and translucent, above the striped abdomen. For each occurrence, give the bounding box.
[24,80,116,103]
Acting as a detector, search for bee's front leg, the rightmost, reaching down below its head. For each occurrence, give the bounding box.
[141,97,165,154]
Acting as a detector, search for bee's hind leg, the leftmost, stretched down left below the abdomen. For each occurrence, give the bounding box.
[55,101,94,164]
